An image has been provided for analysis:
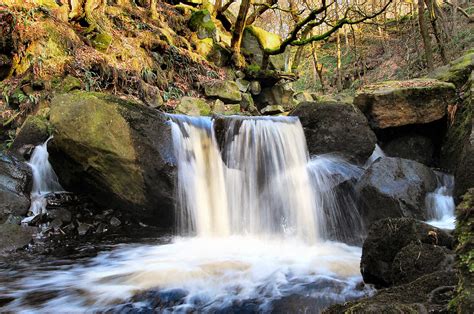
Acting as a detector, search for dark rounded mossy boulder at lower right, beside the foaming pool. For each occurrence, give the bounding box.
[360,218,454,287]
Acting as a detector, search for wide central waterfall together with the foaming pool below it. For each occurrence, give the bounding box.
[0,115,371,312]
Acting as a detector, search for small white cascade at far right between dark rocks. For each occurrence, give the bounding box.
[425,172,456,230]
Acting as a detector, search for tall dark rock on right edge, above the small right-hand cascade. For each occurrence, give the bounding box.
[441,72,474,198]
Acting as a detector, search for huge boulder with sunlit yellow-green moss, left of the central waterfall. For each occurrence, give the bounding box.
[50,92,174,227]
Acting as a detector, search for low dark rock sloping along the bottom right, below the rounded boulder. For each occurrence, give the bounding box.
[323,271,458,314]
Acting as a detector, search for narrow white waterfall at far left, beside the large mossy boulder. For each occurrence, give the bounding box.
[22,136,64,223]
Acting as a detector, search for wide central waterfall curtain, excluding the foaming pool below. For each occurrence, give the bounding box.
[170,115,362,242]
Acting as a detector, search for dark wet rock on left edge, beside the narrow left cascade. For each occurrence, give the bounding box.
[0,153,32,223]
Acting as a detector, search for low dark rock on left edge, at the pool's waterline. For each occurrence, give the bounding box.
[0,224,37,253]
